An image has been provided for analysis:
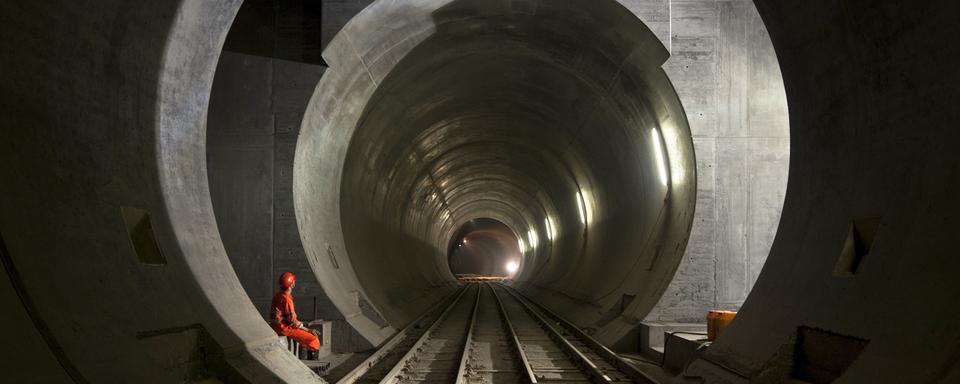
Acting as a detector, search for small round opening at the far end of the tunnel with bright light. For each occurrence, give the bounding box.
[447,218,522,279]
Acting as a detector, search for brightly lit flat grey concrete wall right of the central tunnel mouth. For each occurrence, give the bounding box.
[622,0,790,322]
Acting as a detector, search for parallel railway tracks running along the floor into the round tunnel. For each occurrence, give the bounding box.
[338,283,656,384]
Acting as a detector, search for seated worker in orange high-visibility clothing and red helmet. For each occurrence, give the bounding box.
[270,272,320,359]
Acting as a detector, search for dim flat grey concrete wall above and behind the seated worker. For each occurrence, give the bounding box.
[207,51,342,319]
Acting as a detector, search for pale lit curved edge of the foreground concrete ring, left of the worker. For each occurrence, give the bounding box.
[143,2,316,382]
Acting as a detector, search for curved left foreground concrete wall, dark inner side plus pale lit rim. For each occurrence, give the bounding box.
[0,1,319,383]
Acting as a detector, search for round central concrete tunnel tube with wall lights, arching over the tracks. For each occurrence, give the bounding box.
[294,1,696,344]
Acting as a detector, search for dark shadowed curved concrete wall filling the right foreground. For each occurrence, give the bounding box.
[688,0,960,383]
